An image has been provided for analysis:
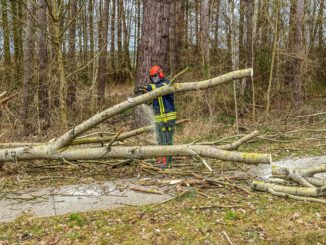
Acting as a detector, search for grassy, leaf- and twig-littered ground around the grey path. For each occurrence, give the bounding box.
[0,106,326,244]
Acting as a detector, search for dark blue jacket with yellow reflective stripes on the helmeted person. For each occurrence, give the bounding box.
[147,78,177,122]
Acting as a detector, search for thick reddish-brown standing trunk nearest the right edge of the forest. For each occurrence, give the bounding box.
[291,0,304,108]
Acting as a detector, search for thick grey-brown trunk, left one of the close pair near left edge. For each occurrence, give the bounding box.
[22,0,35,135]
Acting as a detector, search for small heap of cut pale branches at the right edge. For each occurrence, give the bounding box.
[252,164,326,204]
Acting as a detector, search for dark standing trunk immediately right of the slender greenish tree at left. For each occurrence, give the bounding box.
[67,0,77,110]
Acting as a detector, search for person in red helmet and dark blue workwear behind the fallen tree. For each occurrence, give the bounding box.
[146,66,176,168]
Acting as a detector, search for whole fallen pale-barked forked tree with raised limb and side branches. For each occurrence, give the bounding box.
[0,68,271,171]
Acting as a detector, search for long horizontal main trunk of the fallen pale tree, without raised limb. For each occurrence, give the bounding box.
[0,145,272,164]
